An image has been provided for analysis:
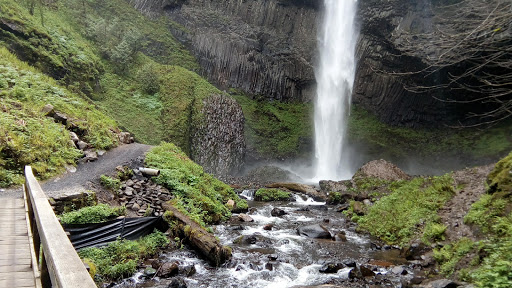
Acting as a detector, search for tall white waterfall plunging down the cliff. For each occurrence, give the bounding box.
[314,0,357,180]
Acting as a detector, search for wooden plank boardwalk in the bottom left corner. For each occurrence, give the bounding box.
[0,198,36,287]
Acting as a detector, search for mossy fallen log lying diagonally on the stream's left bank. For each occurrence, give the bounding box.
[162,203,231,267]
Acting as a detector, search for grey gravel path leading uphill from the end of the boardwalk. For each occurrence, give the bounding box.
[0,143,152,198]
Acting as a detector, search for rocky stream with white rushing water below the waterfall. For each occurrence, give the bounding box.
[112,190,409,288]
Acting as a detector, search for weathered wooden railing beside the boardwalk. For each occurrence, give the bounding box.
[24,166,96,288]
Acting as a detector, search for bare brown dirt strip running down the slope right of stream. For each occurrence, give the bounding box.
[439,164,494,241]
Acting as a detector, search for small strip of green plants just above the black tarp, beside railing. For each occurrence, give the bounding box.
[59,204,126,224]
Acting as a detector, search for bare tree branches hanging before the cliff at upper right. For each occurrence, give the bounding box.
[389,0,512,125]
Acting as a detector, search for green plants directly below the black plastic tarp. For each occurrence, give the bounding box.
[78,231,170,282]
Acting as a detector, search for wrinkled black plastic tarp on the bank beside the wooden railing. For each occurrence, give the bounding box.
[62,217,167,250]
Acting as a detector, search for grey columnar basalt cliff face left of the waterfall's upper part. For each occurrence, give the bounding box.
[132,0,321,100]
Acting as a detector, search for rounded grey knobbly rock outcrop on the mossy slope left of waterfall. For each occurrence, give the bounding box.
[191,95,246,177]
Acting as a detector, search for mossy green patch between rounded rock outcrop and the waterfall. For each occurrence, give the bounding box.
[233,93,313,158]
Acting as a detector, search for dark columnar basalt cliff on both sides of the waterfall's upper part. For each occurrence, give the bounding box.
[131,0,503,127]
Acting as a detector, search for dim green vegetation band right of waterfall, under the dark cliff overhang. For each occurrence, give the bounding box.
[348,106,512,159]
